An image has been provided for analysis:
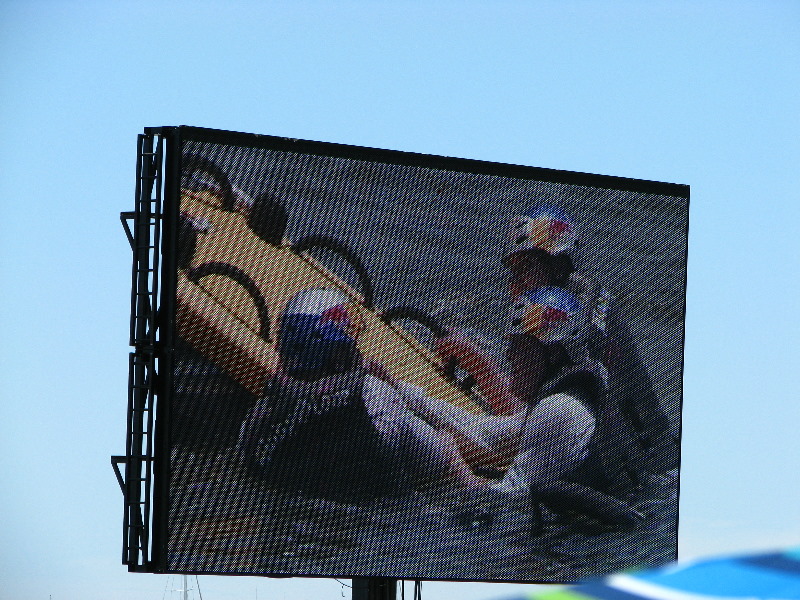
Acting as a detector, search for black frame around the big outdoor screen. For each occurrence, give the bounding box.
[129,126,690,583]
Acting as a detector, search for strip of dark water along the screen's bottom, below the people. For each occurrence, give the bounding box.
[170,451,677,581]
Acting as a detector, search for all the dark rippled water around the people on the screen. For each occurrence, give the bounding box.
[169,141,686,581]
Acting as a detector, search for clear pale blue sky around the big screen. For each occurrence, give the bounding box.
[0,0,800,600]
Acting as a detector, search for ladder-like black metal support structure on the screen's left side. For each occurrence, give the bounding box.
[111,129,164,571]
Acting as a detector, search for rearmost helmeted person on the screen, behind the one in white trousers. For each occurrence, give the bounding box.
[437,205,677,496]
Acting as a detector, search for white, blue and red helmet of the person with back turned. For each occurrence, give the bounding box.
[277,288,360,379]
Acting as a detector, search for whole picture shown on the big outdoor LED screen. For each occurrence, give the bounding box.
[166,130,688,582]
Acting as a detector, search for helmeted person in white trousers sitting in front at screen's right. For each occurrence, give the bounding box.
[408,286,605,490]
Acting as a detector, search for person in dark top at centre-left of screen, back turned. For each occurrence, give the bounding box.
[237,288,478,497]
